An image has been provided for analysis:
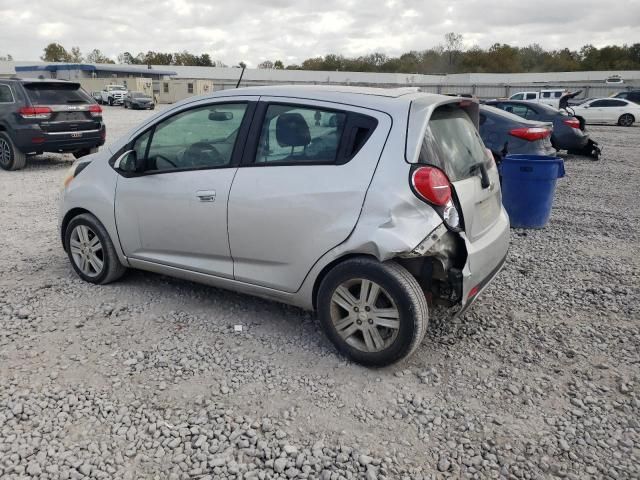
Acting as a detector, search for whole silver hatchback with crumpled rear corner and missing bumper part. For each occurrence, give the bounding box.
[60,86,509,366]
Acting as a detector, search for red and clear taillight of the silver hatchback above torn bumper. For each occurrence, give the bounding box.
[411,166,460,231]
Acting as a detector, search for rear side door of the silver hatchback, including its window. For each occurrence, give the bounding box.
[229,97,391,292]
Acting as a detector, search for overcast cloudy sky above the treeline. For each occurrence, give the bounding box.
[0,0,640,66]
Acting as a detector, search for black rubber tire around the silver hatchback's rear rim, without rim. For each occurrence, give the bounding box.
[317,257,429,367]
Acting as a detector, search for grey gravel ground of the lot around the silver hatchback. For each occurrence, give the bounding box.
[0,107,640,480]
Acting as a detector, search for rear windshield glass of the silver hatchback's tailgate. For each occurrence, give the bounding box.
[418,106,488,182]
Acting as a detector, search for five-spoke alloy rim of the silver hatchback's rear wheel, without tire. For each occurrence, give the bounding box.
[330,278,400,353]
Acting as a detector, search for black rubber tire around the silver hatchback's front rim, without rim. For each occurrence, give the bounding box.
[64,213,127,285]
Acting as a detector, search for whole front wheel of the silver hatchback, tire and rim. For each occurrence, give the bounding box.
[64,213,126,285]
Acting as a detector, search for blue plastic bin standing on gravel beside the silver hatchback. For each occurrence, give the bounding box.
[500,155,564,228]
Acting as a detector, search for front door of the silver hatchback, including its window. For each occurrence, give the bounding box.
[115,101,252,278]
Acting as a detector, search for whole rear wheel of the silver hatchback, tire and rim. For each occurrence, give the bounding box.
[317,258,429,367]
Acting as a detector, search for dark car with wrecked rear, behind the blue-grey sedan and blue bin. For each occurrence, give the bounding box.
[485,100,600,157]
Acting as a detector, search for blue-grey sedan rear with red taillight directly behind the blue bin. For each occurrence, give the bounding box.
[480,105,556,163]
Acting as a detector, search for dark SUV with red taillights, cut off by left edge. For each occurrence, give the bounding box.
[0,78,106,170]
